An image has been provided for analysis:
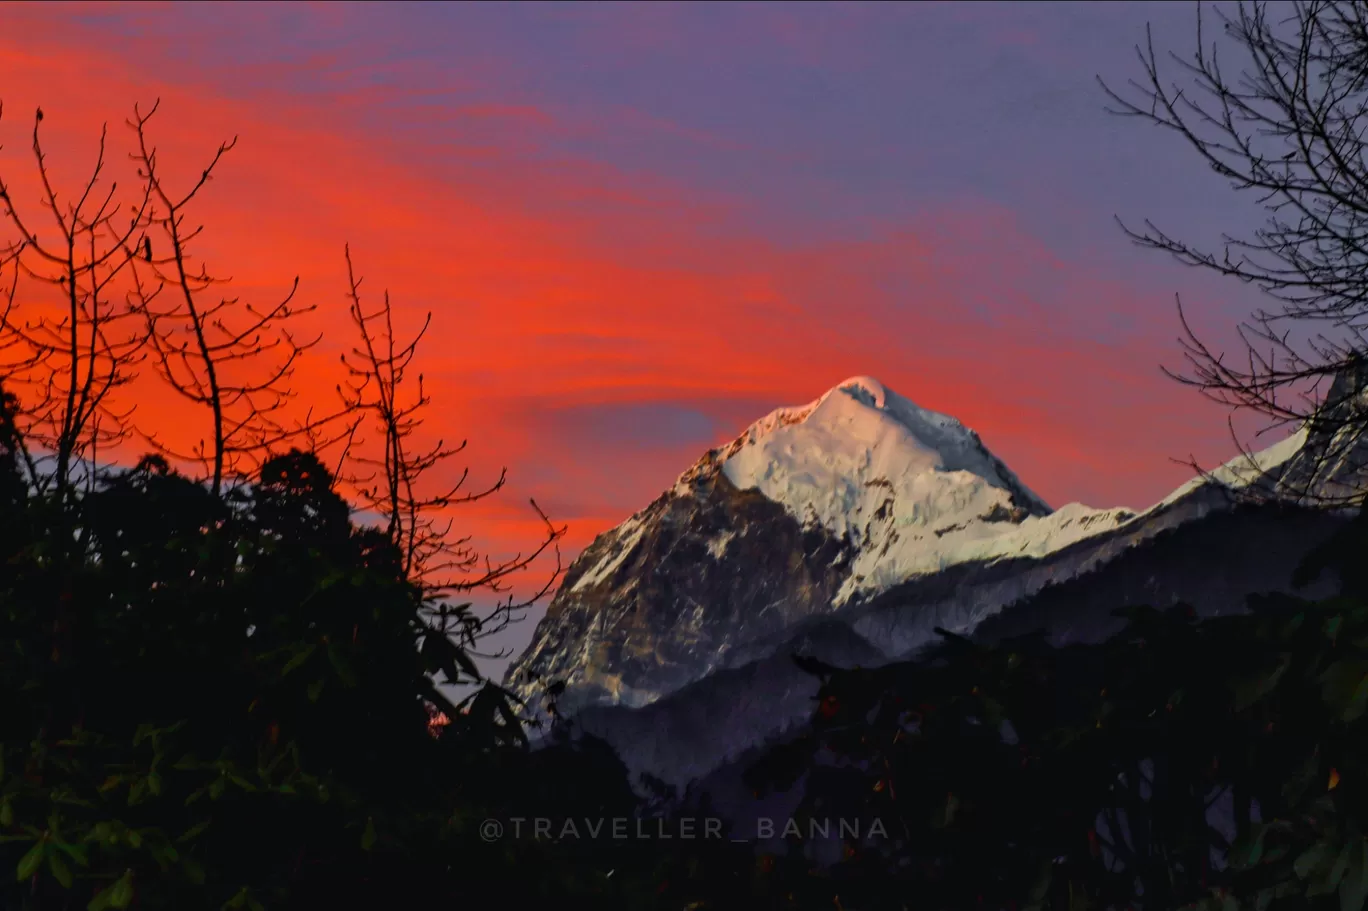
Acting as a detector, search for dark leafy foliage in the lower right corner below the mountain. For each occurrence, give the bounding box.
[751,506,1368,910]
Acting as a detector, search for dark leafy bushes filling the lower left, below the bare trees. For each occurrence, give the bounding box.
[0,374,771,911]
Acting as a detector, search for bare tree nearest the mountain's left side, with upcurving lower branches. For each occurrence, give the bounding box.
[338,246,566,657]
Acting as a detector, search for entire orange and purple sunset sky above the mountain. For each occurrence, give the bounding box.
[0,3,1271,672]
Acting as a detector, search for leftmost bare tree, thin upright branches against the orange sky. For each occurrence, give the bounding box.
[0,107,148,498]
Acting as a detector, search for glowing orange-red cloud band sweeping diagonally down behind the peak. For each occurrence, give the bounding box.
[0,5,1242,601]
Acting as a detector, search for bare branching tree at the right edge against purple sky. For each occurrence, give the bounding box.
[1099,3,1368,505]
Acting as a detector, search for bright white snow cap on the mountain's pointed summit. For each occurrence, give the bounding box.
[718,376,1134,602]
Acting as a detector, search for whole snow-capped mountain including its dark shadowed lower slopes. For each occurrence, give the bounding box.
[506,378,1351,785]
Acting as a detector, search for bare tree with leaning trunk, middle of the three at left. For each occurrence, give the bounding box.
[129,104,335,494]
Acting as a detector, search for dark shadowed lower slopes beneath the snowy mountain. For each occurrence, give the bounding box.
[573,497,1342,788]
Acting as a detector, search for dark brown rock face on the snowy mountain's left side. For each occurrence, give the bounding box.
[508,472,850,713]
